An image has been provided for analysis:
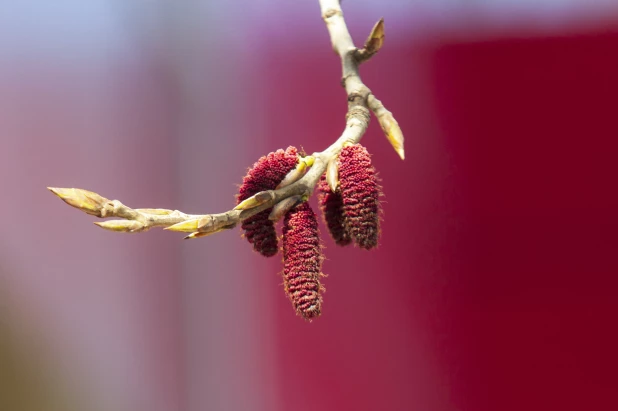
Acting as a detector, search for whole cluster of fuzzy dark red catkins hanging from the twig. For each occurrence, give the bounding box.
[238,144,380,320]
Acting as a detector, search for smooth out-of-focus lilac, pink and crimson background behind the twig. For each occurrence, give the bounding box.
[0,0,618,411]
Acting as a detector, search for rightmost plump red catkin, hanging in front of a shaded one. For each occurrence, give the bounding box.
[339,144,381,250]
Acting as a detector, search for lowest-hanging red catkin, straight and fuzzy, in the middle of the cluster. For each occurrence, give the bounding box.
[283,202,324,320]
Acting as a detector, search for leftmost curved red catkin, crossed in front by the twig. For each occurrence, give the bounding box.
[236,146,298,257]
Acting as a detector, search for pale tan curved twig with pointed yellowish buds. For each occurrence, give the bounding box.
[49,0,404,238]
